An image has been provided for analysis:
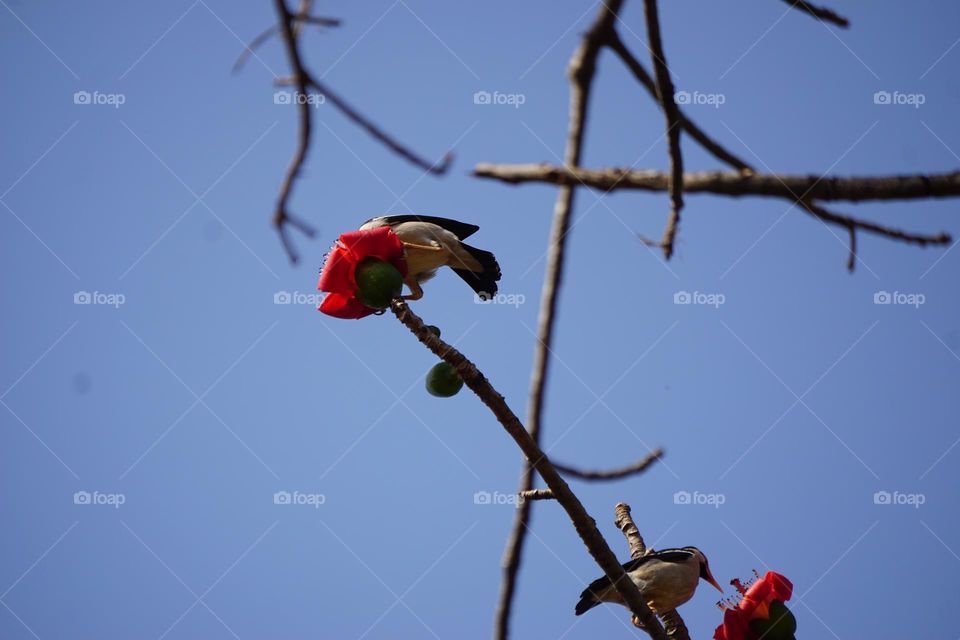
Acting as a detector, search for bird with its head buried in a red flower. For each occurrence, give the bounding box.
[360,215,500,300]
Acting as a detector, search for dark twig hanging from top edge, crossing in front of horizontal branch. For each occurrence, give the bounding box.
[643,0,683,260]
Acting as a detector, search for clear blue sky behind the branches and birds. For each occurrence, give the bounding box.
[0,0,960,640]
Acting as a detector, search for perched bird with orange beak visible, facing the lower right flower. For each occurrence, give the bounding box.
[574,547,723,616]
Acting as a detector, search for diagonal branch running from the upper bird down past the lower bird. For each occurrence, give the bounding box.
[390,300,667,640]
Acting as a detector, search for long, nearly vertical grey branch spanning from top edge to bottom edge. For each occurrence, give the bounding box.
[494,0,623,640]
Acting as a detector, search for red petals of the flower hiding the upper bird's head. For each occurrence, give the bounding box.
[317,226,407,319]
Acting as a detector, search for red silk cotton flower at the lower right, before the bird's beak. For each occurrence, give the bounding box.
[713,571,796,640]
